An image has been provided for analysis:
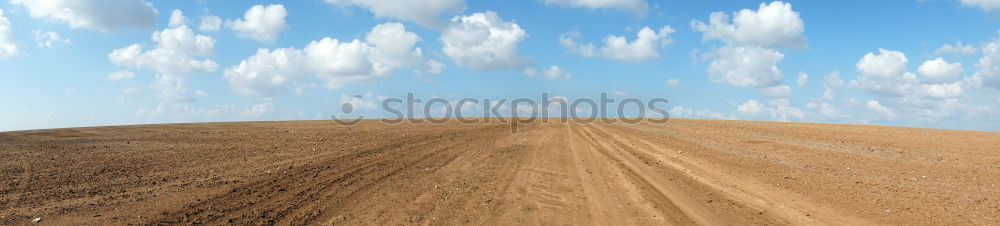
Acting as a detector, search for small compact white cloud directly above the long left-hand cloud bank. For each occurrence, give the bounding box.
[226,4,288,42]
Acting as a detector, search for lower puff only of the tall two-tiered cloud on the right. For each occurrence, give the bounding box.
[704,46,785,87]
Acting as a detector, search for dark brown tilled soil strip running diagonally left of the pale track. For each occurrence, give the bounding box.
[157,126,508,224]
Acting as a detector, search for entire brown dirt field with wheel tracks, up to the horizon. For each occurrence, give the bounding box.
[0,120,1000,225]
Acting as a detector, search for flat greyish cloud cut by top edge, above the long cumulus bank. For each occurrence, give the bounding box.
[326,0,465,29]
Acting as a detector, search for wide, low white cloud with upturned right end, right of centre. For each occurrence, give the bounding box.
[559,26,675,62]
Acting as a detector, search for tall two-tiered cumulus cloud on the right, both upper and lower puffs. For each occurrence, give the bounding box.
[691,1,808,98]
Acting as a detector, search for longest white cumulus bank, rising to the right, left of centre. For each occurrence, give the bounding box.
[224,23,443,97]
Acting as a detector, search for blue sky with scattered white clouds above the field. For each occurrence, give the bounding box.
[0,0,1000,132]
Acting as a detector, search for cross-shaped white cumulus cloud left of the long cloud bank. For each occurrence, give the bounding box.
[108,9,219,100]
